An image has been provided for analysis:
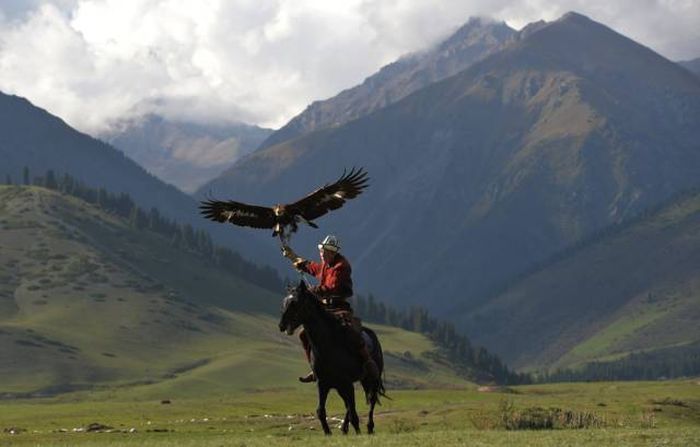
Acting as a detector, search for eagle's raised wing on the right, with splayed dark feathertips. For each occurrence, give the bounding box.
[286,168,369,221]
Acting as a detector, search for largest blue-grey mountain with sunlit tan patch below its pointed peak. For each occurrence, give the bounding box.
[194,13,700,326]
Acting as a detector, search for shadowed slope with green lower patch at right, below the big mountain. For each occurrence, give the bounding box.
[466,193,700,368]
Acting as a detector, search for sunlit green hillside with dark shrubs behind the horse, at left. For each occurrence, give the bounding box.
[0,186,474,396]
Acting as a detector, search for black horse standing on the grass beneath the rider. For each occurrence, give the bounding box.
[279,280,385,435]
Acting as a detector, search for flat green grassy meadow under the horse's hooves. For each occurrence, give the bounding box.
[0,377,700,447]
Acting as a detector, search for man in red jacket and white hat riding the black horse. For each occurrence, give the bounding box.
[282,235,379,383]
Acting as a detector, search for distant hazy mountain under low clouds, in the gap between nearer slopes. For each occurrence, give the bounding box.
[97,114,272,193]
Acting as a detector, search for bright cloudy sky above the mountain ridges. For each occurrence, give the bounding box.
[0,0,700,135]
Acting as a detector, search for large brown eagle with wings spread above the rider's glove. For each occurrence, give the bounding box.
[199,168,369,244]
